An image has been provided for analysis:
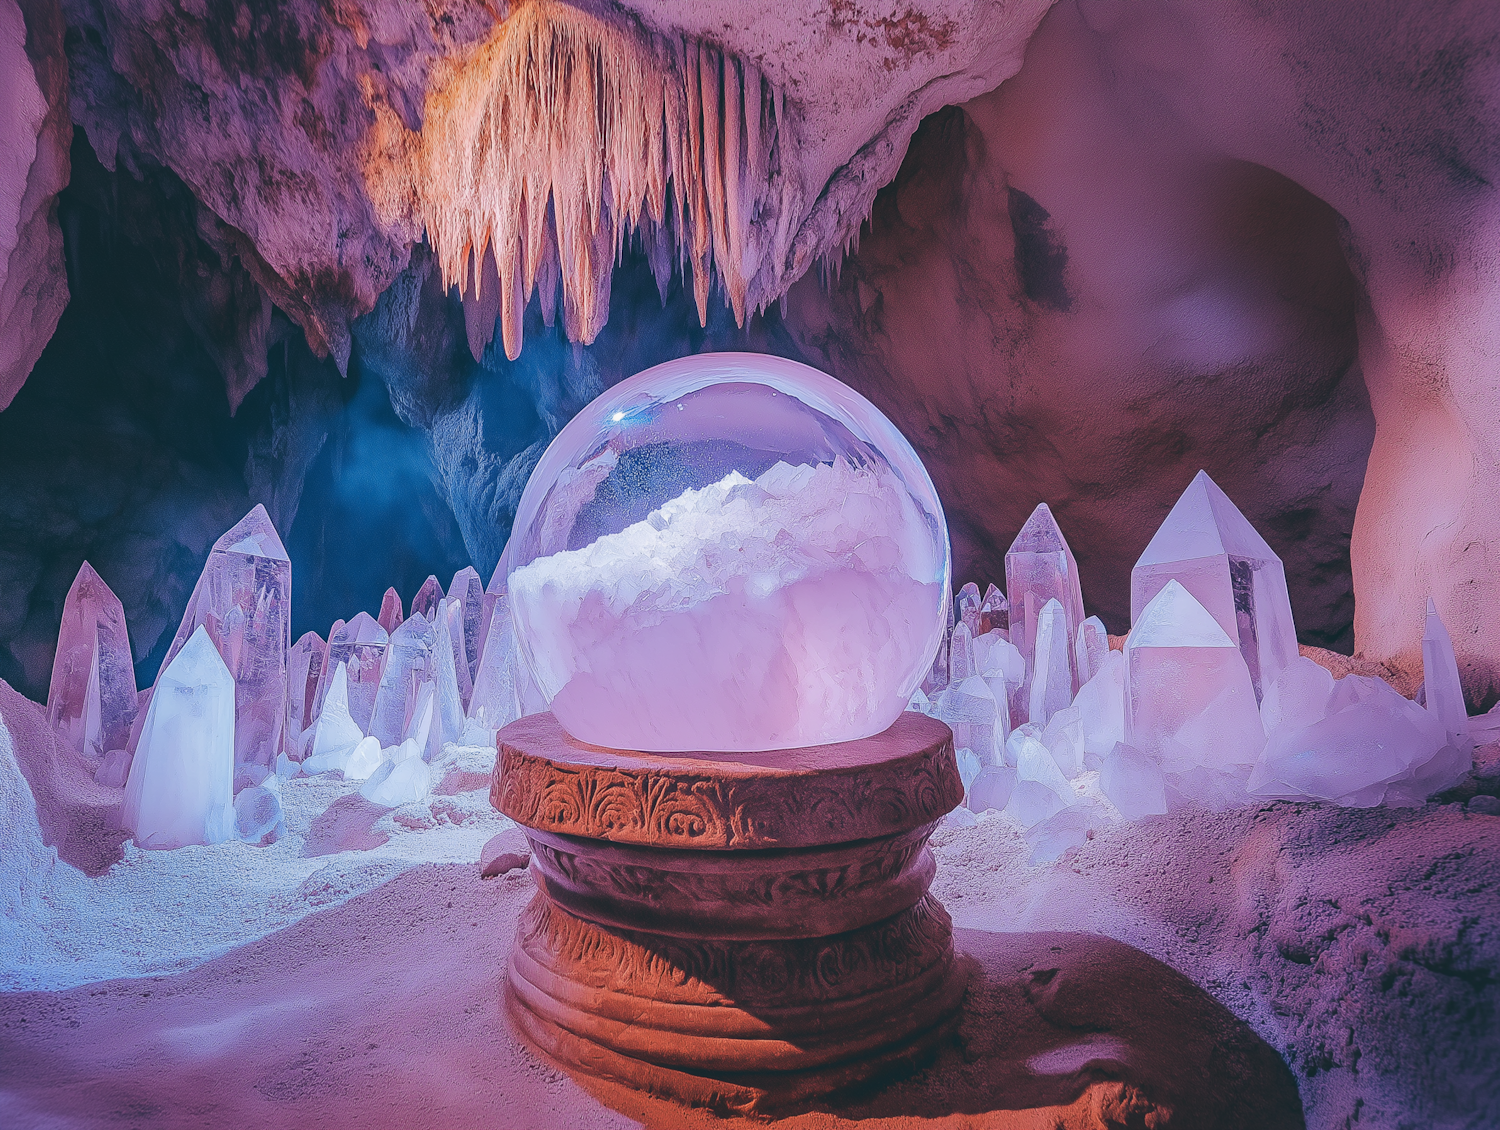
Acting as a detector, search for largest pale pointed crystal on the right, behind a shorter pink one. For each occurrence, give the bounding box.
[1130,471,1298,699]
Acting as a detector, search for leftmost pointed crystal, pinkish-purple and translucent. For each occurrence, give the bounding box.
[47,561,137,758]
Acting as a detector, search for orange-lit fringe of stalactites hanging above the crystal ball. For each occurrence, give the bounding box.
[422,0,801,359]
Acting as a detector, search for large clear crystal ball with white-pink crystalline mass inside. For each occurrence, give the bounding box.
[506,353,951,753]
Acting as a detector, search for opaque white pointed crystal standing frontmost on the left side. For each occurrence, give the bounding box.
[120,626,236,848]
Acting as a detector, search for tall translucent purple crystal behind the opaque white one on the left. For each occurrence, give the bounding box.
[153,504,291,765]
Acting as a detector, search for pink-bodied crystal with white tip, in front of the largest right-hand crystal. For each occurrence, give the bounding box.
[1125,579,1265,773]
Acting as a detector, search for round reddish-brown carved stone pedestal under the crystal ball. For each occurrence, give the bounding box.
[491,713,963,1109]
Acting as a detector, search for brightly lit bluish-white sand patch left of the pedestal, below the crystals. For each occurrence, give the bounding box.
[0,744,513,992]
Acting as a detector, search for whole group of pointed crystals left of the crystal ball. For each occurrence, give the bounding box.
[48,506,545,848]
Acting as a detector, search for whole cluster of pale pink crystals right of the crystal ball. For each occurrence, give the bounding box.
[909,473,1476,860]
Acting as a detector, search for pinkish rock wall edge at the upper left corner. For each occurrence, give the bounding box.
[0,0,74,411]
